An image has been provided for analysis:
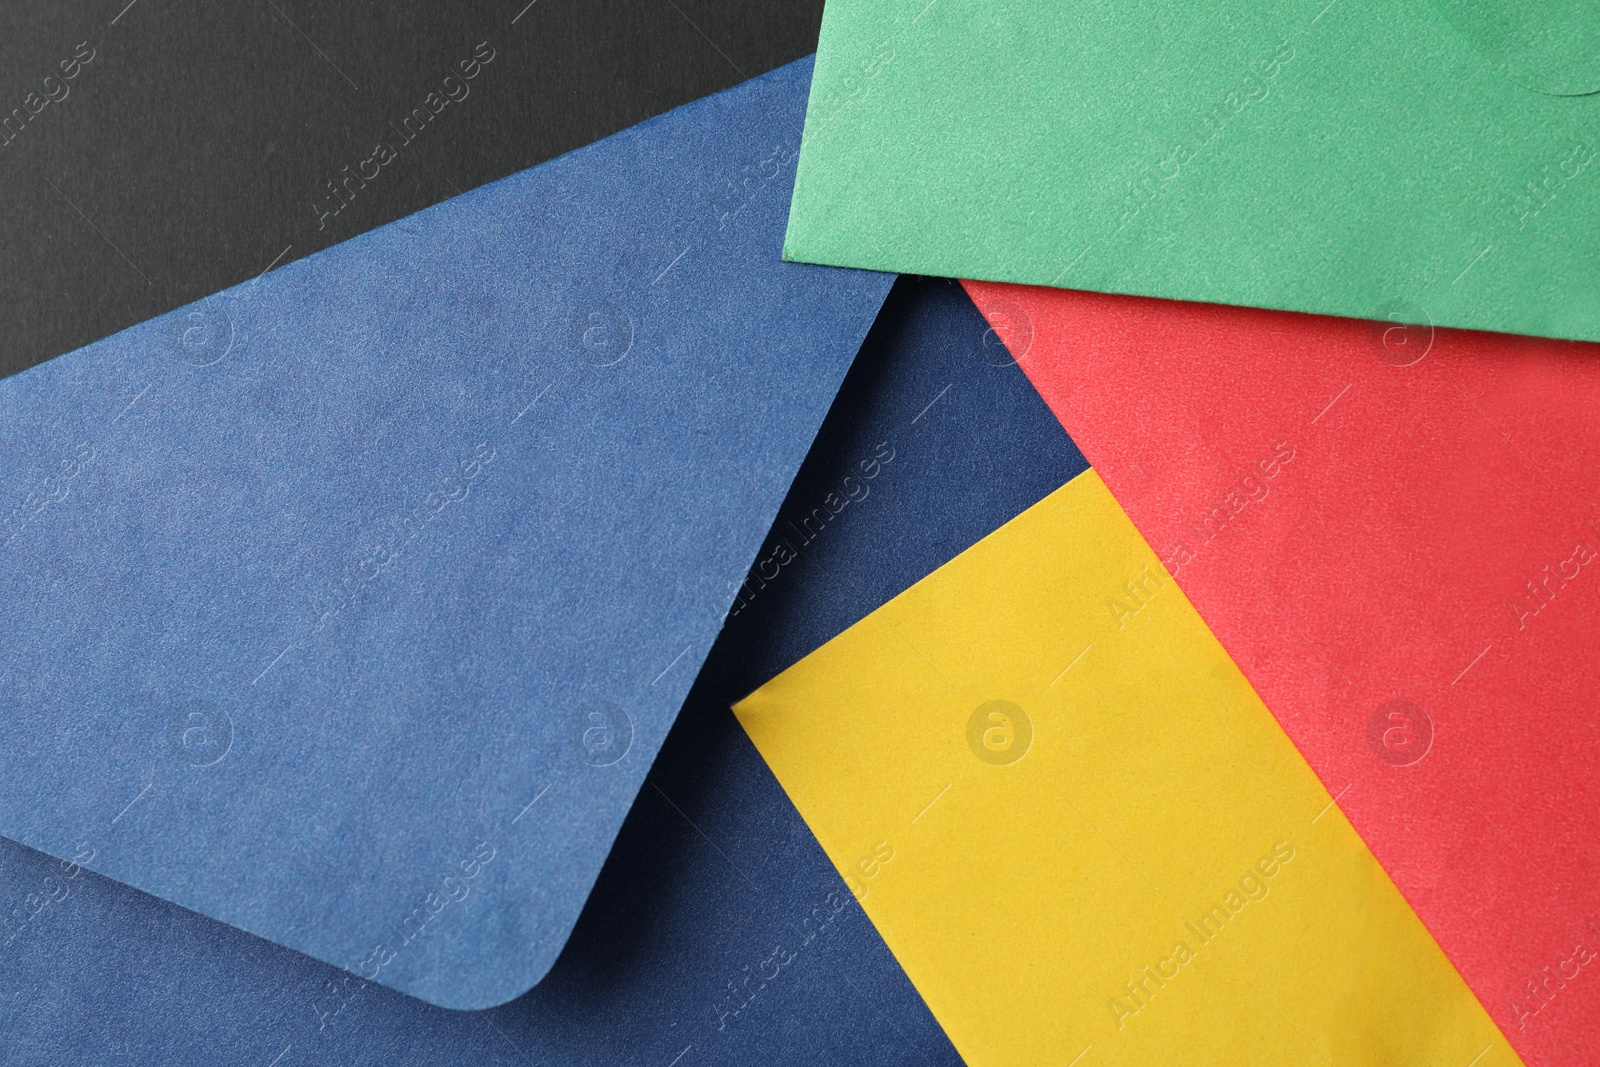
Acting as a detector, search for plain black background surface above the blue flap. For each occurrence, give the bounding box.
[0,0,822,376]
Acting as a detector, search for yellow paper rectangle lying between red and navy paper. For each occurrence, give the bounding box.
[736,472,1518,1067]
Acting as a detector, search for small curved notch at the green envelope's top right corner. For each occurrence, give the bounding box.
[1429,0,1600,96]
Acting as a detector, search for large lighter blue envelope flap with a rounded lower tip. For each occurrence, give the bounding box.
[0,61,893,1008]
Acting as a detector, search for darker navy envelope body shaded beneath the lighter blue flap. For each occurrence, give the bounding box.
[0,278,1086,1067]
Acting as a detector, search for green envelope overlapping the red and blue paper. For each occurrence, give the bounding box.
[784,0,1600,341]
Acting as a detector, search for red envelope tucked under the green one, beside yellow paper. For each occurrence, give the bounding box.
[966,282,1600,1067]
